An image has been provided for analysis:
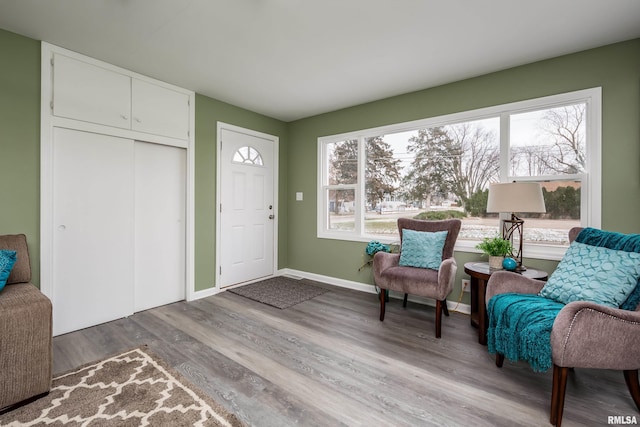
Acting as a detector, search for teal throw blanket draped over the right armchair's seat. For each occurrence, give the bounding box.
[487,293,564,372]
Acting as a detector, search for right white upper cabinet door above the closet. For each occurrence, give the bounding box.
[131,78,189,140]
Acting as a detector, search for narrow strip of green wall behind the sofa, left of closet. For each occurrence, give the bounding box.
[0,30,40,284]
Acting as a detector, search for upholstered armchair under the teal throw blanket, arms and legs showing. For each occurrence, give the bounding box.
[486,227,640,427]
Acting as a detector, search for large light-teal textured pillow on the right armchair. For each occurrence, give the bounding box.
[540,242,640,308]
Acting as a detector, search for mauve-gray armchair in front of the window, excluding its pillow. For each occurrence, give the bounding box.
[373,218,462,338]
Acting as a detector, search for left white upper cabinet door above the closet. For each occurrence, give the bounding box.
[53,54,131,129]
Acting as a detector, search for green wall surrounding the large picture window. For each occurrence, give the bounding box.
[288,39,640,302]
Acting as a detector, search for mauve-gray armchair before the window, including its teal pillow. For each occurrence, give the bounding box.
[373,218,461,338]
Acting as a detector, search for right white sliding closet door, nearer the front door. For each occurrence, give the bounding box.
[135,141,187,311]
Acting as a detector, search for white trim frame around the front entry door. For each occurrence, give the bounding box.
[214,122,280,291]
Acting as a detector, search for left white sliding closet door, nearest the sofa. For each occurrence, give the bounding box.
[52,128,134,335]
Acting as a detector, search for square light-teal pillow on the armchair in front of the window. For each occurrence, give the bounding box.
[400,229,448,270]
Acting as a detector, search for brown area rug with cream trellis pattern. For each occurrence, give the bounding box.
[0,347,243,427]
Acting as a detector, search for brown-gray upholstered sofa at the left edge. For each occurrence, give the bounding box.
[0,234,53,411]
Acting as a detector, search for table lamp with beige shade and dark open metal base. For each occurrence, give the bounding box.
[487,182,546,270]
